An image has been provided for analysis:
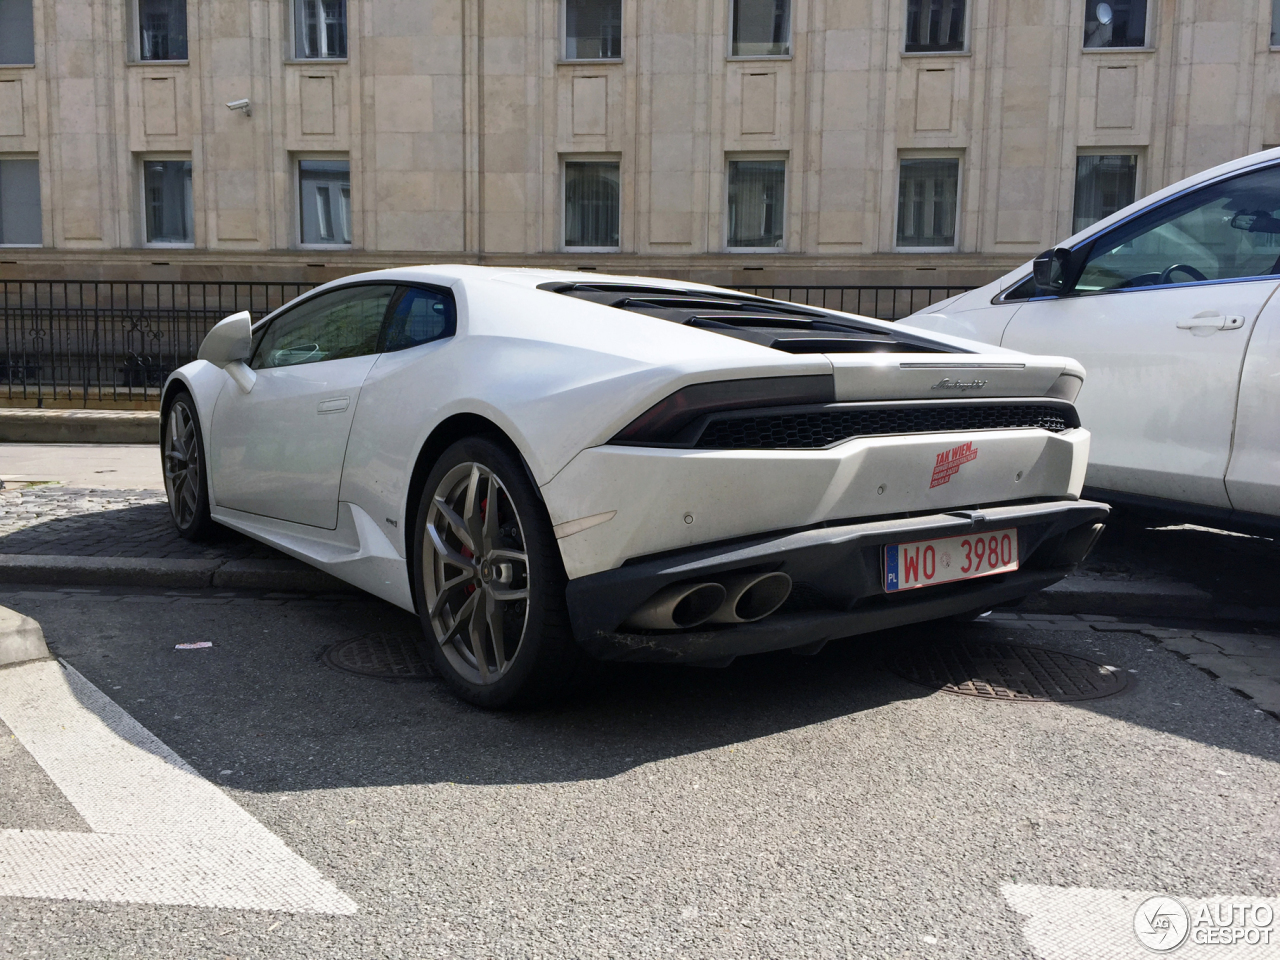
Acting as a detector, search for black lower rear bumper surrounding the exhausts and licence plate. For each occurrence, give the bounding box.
[567,500,1110,662]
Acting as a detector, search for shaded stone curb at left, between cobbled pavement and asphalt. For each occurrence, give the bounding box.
[0,554,356,593]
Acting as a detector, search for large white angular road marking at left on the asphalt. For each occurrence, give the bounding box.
[0,660,357,914]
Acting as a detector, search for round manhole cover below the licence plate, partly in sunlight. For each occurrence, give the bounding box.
[886,640,1128,703]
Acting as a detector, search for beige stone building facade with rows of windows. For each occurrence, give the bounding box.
[0,0,1280,284]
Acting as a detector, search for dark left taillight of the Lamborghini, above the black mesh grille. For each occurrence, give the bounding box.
[613,374,836,443]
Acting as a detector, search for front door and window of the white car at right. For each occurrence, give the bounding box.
[1001,166,1280,508]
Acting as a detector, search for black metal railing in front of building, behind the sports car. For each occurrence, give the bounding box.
[0,280,972,407]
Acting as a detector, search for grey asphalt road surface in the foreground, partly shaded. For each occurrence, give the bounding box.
[0,593,1280,959]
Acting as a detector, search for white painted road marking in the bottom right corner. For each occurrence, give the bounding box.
[1000,883,1280,960]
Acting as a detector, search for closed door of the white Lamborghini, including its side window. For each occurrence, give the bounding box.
[209,284,396,530]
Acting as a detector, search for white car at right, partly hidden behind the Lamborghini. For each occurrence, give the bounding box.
[901,150,1280,530]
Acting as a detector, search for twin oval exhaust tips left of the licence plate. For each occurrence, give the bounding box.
[622,573,791,630]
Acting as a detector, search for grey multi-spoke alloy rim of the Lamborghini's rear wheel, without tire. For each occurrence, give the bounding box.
[422,462,530,685]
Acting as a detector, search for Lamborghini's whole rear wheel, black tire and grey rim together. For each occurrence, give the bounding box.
[413,436,589,709]
